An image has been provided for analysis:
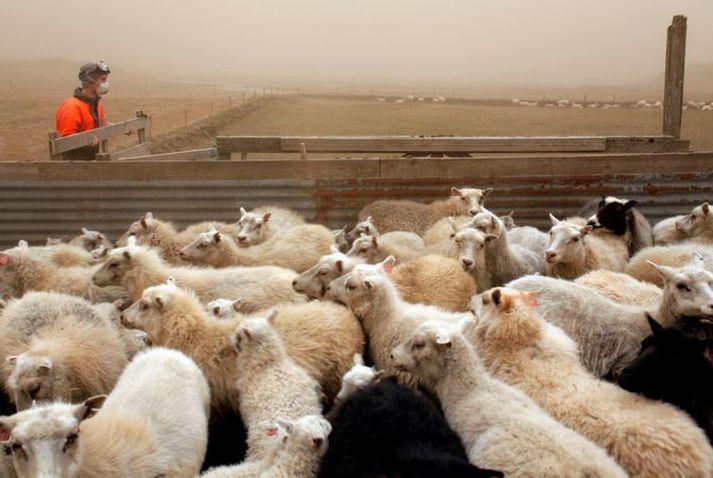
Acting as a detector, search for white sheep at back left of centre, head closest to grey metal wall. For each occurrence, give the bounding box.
[237,206,305,247]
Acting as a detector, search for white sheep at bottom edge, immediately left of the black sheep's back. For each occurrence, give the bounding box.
[201,415,332,478]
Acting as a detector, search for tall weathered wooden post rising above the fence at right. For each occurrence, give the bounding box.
[663,15,687,138]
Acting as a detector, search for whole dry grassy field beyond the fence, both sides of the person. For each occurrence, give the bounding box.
[0,93,713,161]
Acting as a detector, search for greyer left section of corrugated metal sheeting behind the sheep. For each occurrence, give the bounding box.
[0,180,315,248]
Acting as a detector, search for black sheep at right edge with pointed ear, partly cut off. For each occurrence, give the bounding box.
[619,317,713,443]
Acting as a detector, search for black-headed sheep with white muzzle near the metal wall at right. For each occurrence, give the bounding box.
[580,197,654,256]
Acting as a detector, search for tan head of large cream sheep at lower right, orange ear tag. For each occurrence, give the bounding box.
[471,287,542,347]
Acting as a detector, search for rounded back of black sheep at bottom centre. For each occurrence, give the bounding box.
[318,380,503,478]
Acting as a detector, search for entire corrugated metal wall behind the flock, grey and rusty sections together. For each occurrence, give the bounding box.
[0,171,713,247]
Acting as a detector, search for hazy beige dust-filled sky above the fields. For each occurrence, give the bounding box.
[0,0,713,86]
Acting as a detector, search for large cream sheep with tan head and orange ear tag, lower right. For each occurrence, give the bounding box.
[468,289,713,478]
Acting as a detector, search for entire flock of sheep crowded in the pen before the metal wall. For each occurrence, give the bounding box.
[0,188,713,478]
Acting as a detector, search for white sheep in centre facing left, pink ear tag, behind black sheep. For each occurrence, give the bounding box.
[344,258,470,383]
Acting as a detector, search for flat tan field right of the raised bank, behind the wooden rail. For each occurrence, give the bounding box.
[221,97,713,150]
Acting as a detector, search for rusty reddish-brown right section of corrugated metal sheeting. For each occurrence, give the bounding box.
[317,171,713,228]
